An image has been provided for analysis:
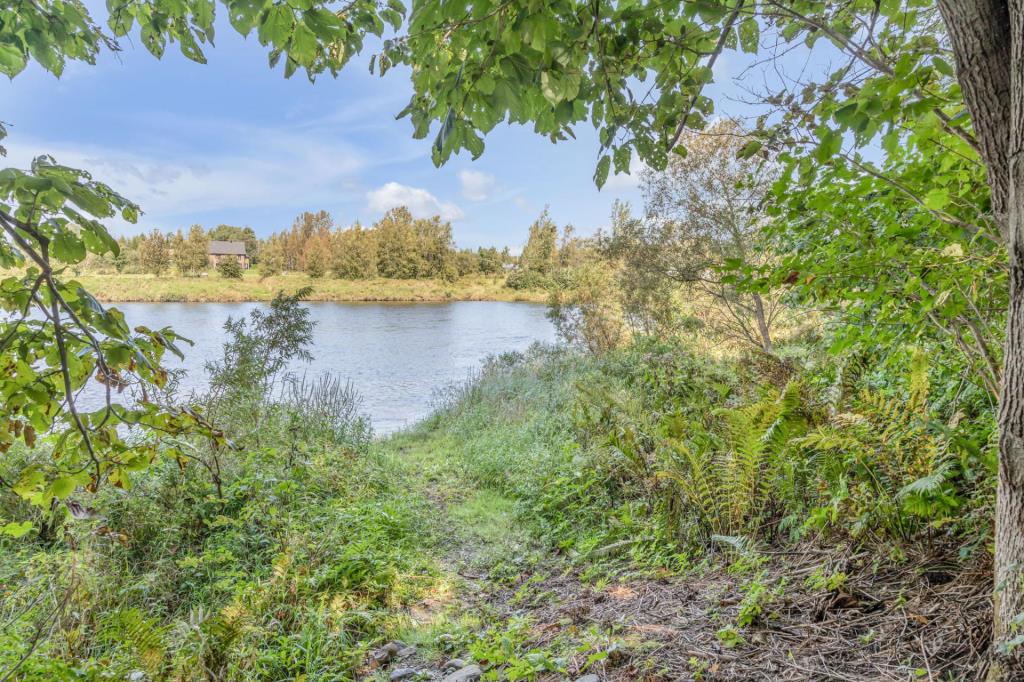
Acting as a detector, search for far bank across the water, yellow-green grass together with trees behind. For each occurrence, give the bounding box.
[61,208,536,301]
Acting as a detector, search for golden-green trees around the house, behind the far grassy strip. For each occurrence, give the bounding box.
[88,207,518,282]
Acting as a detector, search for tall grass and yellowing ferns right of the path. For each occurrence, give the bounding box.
[433,333,994,561]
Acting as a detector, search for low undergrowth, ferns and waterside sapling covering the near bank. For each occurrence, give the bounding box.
[0,327,994,680]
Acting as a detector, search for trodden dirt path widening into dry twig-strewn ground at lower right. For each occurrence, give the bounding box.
[366,436,989,682]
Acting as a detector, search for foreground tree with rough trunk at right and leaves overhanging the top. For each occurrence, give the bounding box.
[6,0,1024,663]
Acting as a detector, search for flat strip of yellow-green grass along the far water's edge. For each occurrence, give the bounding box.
[59,272,545,303]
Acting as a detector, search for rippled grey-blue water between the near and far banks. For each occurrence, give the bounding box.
[114,301,555,433]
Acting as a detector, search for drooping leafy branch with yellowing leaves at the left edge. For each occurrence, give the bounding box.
[0,157,222,532]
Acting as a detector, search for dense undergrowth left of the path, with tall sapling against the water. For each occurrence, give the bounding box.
[0,284,395,680]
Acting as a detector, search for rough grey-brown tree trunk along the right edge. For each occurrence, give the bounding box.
[939,0,1024,682]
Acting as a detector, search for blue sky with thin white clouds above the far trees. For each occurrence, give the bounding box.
[0,2,770,249]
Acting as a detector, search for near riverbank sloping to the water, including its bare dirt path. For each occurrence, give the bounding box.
[0,337,992,682]
